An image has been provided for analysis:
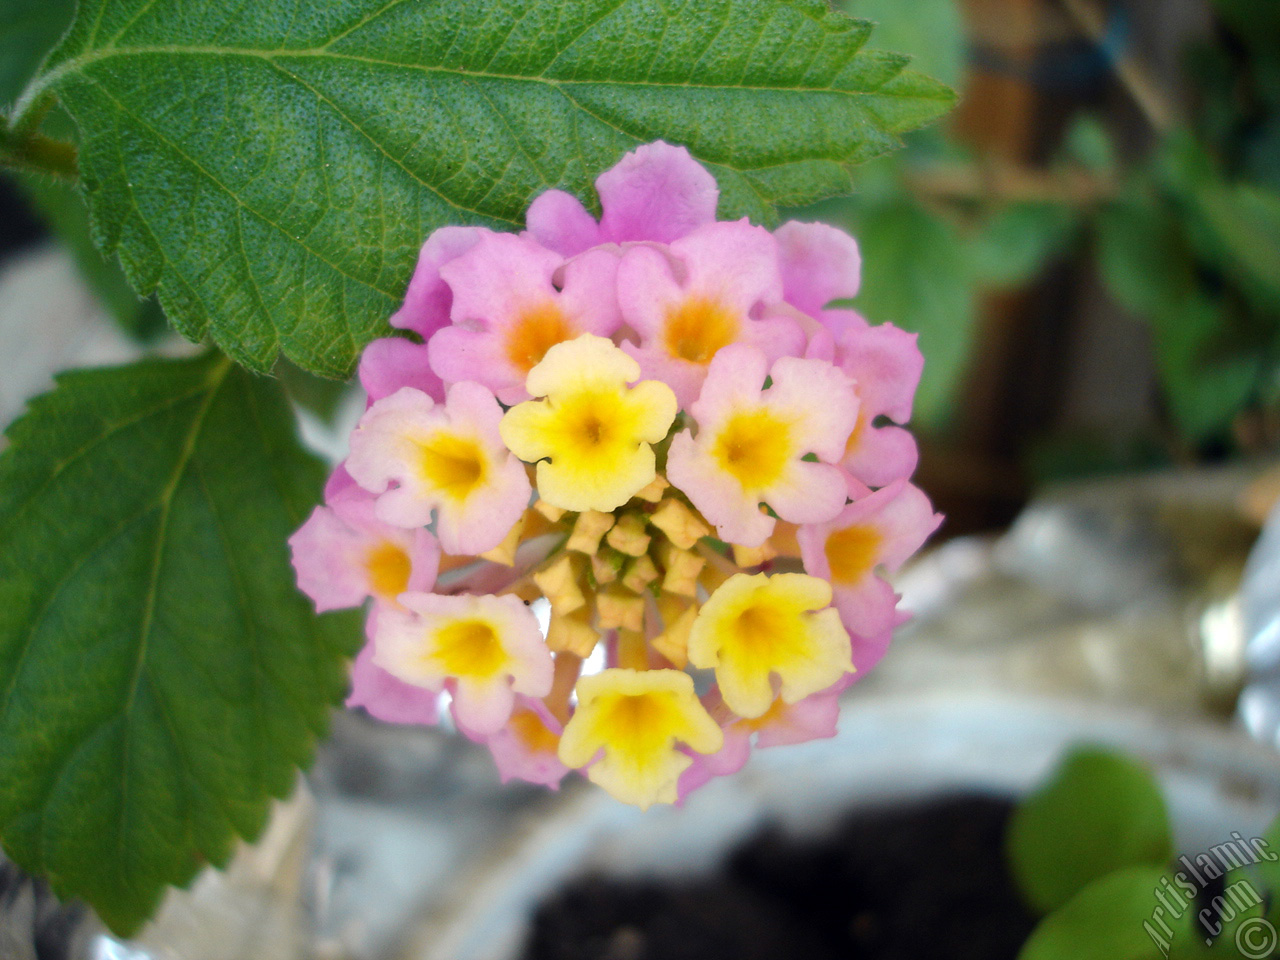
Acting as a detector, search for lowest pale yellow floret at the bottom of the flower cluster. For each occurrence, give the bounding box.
[559,668,724,809]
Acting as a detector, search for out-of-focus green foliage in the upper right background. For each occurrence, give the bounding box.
[829,0,1280,458]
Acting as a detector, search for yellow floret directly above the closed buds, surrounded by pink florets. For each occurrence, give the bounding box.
[500,334,676,512]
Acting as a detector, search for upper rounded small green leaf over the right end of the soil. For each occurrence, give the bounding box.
[1006,748,1172,913]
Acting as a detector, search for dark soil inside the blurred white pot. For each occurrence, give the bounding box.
[525,796,1036,960]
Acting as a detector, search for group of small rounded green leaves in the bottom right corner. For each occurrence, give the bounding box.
[1006,748,1280,960]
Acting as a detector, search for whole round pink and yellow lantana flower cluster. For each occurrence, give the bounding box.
[291,142,941,808]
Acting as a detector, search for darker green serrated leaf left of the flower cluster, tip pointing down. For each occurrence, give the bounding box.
[0,356,360,932]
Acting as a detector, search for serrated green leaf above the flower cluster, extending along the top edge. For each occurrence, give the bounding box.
[10,0,952,376]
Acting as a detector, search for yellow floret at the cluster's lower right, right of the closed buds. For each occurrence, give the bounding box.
[689,573,854,717]
